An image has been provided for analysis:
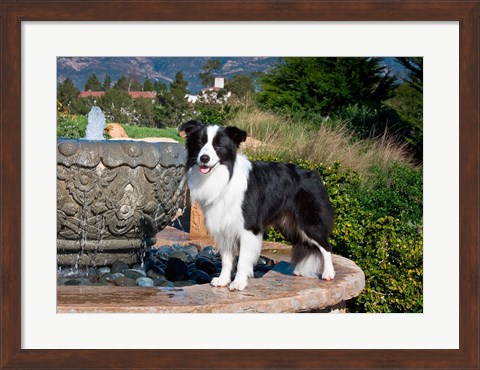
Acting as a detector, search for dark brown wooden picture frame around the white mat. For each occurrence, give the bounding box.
[0,0,480,369]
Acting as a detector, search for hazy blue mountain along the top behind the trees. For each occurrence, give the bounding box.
[57,57,403,93]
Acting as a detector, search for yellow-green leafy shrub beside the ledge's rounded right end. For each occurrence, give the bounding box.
[331,196,423,312]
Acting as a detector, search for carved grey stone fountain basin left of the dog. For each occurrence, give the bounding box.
[57,139,185,266]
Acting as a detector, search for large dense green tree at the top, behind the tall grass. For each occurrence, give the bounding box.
[257,57,395,116]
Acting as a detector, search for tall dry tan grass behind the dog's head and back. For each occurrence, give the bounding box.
[227,107,413,175]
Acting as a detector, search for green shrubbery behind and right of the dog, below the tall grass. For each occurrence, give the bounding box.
[252,157,423,312]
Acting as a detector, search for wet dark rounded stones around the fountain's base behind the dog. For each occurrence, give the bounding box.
[57,244,278,287]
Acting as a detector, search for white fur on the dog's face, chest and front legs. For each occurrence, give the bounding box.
[188,137,262,290]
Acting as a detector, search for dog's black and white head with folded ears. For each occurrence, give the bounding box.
[178,121,247,177]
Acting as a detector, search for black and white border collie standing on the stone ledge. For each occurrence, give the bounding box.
[179,121,335,290]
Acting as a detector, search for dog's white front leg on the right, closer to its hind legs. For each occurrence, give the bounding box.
[229,230,263,290]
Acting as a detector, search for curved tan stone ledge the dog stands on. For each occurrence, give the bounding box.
[57,256,365,313]
